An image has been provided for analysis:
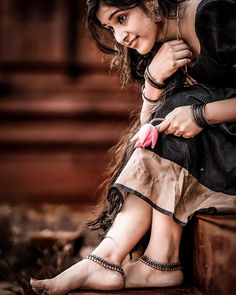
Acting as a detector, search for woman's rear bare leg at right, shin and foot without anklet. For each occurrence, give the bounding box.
[125,209,183,288]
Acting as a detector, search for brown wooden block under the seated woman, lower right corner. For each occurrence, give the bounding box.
[194,215,236,295]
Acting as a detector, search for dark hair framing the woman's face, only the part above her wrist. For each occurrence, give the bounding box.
[87,0,186,86]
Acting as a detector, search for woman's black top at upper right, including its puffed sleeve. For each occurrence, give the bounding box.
[190,0,236,88]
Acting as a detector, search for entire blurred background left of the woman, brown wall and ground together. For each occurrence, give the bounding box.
[0,0,141,295]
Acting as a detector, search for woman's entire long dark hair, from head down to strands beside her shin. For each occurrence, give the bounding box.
[87,0,186,243]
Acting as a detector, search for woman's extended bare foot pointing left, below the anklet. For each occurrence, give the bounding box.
[30,259,124,295]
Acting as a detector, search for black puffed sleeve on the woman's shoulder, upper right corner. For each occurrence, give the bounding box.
[196,0,236,67]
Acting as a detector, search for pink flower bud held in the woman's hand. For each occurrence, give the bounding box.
[130,123,158,148]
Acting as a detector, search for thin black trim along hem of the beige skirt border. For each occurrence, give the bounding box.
[112,183,187,226]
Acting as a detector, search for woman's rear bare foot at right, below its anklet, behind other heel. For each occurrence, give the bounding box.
[124,261,184,288]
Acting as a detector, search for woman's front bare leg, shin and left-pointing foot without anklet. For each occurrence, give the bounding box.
[31,196,152,295]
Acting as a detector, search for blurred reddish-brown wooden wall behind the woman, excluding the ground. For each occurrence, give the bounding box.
[0,0,140,204]
